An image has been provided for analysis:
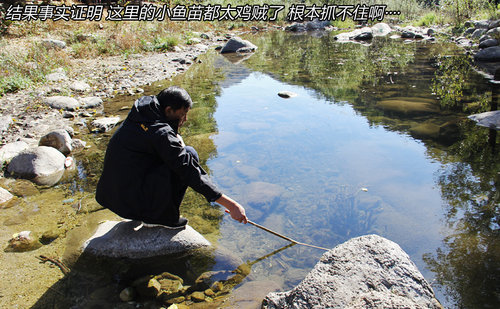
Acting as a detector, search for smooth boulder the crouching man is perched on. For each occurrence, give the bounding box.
[83,221,211,259]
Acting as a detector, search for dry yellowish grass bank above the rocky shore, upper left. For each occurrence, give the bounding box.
[0,12,236,96]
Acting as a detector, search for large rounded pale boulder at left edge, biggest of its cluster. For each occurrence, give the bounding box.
[7,146,66,186]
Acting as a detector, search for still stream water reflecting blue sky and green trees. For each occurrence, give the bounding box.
[193,34,500,308]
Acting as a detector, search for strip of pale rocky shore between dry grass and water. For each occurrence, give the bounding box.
[0,33,228,149]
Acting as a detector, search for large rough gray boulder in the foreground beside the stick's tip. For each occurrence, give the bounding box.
[263,235,442,308]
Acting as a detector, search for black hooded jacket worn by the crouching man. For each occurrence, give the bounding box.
[96,96,221,224]
